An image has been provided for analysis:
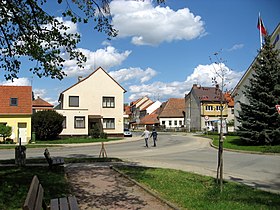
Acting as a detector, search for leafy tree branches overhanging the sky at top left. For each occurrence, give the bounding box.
[0,0,164,80]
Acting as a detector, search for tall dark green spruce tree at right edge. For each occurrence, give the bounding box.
[237,36,280,145]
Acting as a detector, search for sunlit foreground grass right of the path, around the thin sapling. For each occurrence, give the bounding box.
[118,166,280,210]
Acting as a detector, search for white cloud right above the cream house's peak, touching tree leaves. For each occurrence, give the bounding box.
[63,46,131,77]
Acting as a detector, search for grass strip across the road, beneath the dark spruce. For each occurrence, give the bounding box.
[204,135,280,153]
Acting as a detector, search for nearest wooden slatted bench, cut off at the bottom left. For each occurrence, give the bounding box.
[22,175,79,210]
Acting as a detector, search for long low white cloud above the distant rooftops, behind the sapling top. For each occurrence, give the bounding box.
[128,63,244,101]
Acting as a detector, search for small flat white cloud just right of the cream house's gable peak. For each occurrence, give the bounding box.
[109,68,157,83]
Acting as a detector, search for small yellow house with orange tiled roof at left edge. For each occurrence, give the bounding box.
[0,86,32,144]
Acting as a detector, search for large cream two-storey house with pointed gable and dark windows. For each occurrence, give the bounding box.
[56,67,126,136]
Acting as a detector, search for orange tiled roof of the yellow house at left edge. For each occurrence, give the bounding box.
[0,86,32,115]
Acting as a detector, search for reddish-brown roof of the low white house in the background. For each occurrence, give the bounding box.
[159,98,186,117]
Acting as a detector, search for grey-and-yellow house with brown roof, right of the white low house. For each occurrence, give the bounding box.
[185,84,228,131]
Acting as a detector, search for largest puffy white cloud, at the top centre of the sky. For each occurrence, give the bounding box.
[110,0,205,45]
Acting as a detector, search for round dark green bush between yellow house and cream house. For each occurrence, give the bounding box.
[32,110,64,140]
